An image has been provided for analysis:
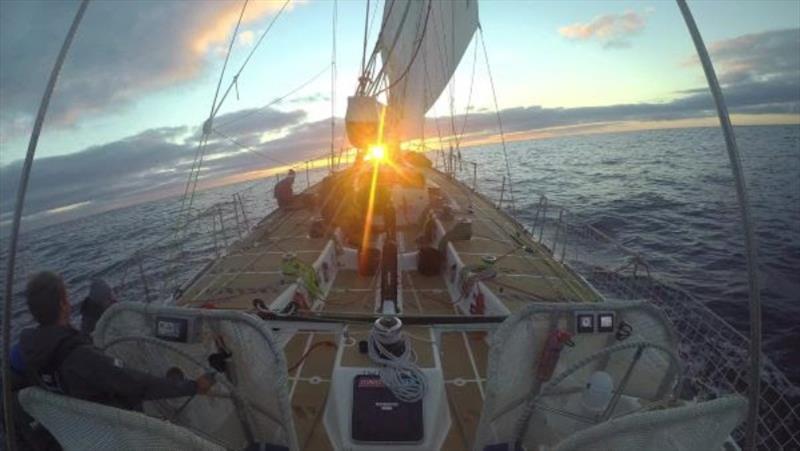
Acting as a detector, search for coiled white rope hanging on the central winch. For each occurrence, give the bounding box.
[367,318,428,402]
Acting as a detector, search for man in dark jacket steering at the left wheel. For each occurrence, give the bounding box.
[20,272,214,410]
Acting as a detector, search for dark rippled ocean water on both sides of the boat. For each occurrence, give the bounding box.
[0,126,800,386]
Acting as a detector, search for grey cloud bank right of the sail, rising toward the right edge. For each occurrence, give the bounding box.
[450,28,800,138]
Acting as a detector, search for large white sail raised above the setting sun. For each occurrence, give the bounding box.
[379,0,478,139]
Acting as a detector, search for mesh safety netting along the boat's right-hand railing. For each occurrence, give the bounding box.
[531,203,800,450]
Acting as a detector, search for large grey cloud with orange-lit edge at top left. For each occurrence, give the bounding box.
[0,1,290,141]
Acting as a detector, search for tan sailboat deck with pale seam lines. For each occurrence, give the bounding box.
[179,170,598,450]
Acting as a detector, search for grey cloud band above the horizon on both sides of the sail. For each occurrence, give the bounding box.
[0,30,800,231]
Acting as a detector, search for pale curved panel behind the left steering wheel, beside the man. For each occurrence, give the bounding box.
[94,303,297,449]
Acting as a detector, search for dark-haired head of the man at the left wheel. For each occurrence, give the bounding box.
[25,271,70,326]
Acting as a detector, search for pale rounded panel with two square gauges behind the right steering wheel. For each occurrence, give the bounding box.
[476,301,682,449]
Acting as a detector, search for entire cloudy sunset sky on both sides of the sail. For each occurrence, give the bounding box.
[0,0,800,230]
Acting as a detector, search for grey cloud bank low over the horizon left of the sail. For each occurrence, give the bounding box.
[0,108,310,228]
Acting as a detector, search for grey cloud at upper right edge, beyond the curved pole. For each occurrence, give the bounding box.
[682,28,800,84]
